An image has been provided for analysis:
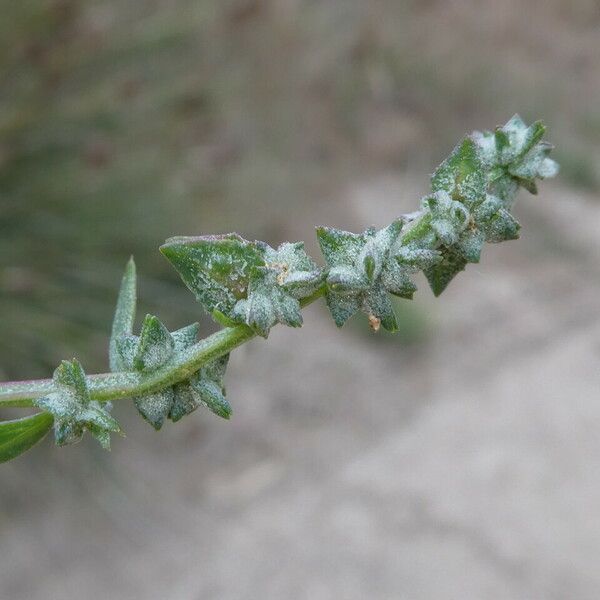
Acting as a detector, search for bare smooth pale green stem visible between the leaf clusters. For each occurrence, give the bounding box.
[0,286,325,408]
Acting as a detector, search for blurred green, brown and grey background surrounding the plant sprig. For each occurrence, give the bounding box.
[0,0,600,600]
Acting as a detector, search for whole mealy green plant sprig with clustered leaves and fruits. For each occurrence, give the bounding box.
[0,115,558,462]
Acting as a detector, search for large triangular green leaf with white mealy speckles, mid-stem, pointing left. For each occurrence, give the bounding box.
[160,233,265,316]
